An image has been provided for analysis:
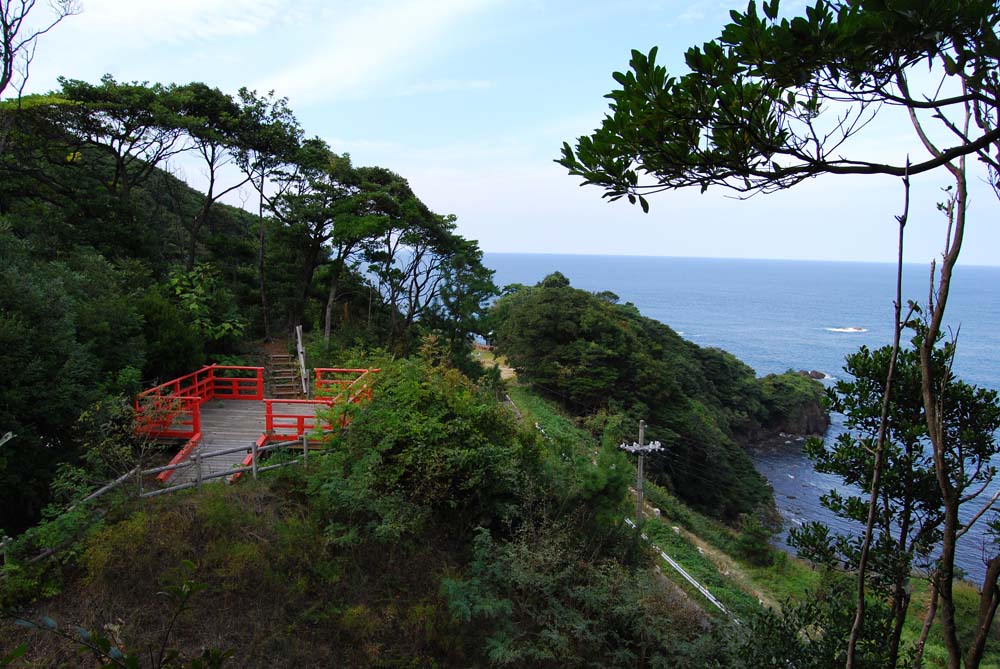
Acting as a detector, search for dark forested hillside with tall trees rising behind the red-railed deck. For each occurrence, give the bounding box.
[0,77,494,533]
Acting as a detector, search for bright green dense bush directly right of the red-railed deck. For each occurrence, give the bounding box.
[310,359,536,541]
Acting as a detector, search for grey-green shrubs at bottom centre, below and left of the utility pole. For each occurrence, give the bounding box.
[442,524,723,667]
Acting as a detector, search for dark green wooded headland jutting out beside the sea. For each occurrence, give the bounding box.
[492,275,819,521]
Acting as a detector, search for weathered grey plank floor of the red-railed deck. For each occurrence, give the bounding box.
[171,400,316,484]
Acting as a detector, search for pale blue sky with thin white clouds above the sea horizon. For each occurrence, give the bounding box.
[15,0,1000,265]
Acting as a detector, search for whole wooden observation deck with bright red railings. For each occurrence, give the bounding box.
[135,365,379,482]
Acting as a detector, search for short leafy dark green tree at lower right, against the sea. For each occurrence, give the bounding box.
[792,336,1000,666]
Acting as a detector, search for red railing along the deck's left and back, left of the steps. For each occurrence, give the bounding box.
[135,365,264,439]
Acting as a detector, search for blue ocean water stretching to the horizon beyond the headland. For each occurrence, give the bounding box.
[485,253,1000,578]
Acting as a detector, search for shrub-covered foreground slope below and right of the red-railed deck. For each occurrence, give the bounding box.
[0,359,724,667]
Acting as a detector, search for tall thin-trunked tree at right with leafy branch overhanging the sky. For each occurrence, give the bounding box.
[558,0,1000,669]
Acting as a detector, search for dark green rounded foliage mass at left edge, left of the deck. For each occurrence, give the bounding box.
[0,224,142,532]
